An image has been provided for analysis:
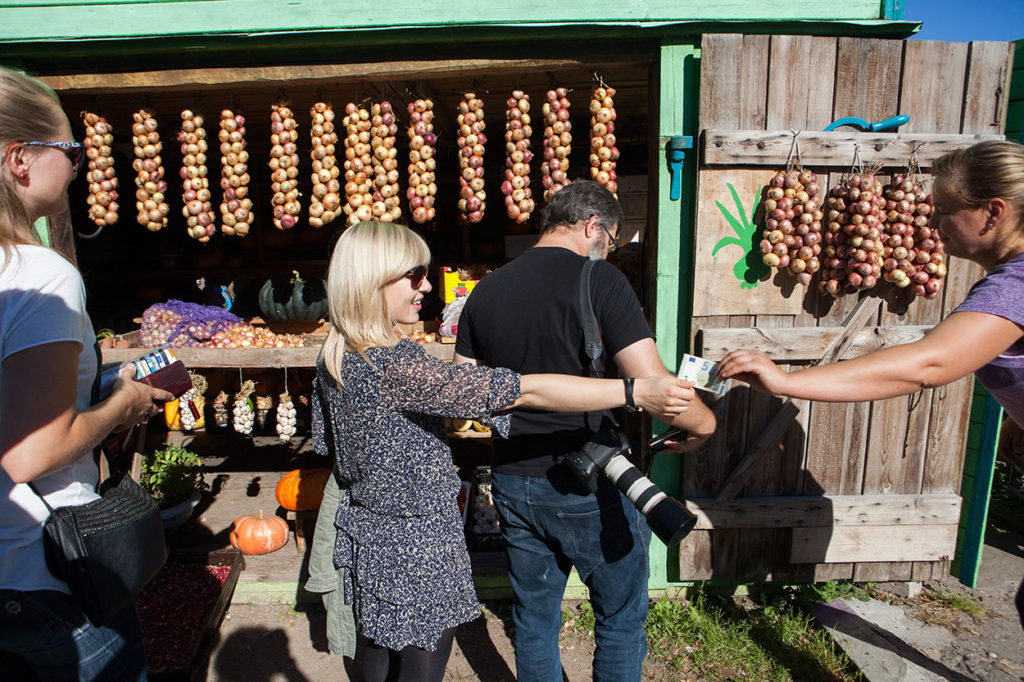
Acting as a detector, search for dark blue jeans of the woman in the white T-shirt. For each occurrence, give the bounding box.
[0,590,146,682]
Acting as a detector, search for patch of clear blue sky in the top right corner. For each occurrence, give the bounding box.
[903,0,1024,42]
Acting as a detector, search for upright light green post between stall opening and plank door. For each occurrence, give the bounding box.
[648,43,700,589]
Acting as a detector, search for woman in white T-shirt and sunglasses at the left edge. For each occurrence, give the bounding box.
[0,68,173,682]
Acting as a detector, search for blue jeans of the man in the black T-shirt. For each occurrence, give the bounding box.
[493,473,650,682]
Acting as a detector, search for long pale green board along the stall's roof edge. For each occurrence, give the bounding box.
[0,0,883,40]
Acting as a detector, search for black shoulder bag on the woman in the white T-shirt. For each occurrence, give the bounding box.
[29,345,167,625]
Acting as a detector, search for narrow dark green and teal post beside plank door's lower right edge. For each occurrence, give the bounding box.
[950,385,1002,588]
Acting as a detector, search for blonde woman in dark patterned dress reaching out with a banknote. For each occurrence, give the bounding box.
[313,222,693,681]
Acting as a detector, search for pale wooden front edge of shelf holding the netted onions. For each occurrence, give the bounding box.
[102,343,455,369]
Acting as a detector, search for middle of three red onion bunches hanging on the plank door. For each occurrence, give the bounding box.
[818,173,885,297]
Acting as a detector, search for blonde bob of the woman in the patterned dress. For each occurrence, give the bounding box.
[321,222,430,386]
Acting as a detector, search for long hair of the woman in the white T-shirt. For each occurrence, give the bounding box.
[0,67,63,255]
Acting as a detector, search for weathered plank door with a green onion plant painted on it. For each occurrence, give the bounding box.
[680,35,1012,581]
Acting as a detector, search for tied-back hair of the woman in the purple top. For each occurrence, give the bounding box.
[932,140,1024,223]
